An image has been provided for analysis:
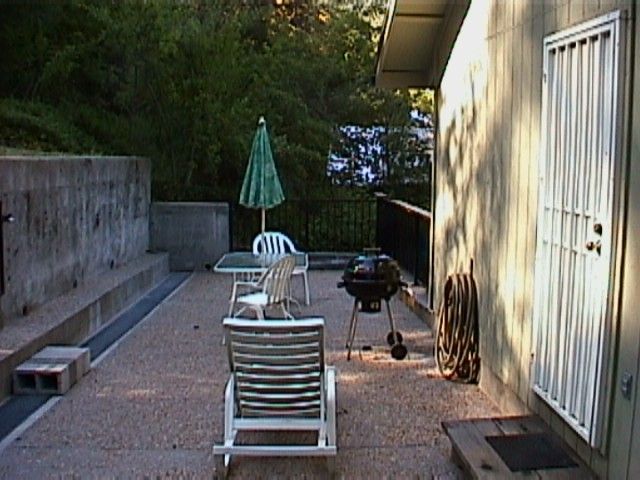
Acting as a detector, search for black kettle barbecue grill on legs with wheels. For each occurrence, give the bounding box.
[338,248,407,360]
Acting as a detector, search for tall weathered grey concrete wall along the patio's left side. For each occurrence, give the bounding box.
[0,156,151,324]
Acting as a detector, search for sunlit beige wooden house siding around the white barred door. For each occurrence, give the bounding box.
[434,0,640,478]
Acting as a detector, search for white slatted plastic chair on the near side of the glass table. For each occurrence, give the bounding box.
[229,255,295,319]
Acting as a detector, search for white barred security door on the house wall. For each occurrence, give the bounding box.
[533,13,620,446]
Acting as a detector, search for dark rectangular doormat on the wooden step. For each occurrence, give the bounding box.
[485,433,578,472]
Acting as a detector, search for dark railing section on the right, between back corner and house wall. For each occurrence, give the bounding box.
[376,194,431,289]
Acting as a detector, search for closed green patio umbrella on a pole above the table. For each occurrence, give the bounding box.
[240,117,284,246]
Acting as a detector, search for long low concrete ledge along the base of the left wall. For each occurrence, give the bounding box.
[0,253,169,402]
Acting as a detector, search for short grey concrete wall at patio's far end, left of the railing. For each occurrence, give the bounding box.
[150,202,229,271]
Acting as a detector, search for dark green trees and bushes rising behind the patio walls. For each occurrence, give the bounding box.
[0,0,411,201]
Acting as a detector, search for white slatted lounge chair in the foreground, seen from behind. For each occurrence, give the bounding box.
[213,317,337,476]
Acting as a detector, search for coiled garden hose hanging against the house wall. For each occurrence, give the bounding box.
[435,273,480,383]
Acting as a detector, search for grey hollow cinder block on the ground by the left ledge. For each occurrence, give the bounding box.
[13,346,91,395]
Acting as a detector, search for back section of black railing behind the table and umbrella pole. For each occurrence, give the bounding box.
[230,198,376,252]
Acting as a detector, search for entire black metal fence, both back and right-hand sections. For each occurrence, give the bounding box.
[230,194,431,289]
